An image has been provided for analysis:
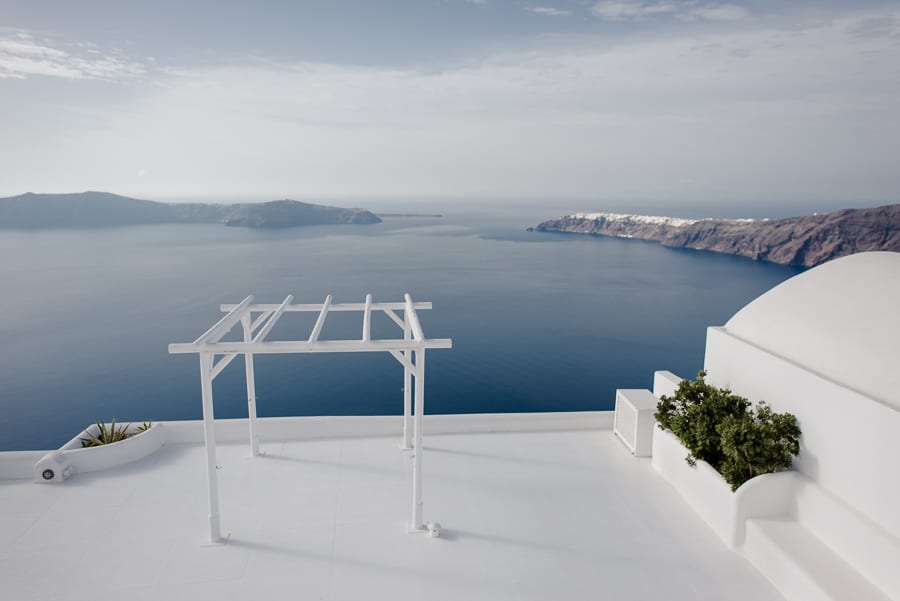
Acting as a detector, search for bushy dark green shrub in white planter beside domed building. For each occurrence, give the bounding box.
[655,371,800,490]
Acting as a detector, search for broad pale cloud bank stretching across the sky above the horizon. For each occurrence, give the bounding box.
[0,8,900,202]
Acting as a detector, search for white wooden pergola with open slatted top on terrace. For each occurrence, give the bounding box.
[169,294,453,542]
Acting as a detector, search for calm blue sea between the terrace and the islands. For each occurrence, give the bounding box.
[0,207,798,450]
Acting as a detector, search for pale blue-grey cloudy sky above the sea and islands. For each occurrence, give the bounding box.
[0,0,900,208]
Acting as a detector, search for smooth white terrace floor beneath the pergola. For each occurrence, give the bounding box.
[0,420,781,601]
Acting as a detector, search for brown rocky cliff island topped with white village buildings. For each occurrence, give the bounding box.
[528,204,900,267]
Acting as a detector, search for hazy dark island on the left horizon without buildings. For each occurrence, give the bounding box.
[0,192,381,229]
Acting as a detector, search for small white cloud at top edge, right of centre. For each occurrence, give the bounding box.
[591,0,750,21]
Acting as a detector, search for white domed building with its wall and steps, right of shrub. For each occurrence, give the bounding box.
[704,252,900,601]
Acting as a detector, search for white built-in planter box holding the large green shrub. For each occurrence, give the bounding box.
[652,426,797,548]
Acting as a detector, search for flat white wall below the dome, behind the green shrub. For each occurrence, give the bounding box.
[705,327,900,538]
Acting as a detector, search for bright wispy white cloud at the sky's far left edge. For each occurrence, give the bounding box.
[0,31,146,79]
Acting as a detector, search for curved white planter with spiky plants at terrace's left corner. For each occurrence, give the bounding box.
[34,424,165,483]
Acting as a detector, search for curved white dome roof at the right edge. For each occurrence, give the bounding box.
[725,252,900,409]
